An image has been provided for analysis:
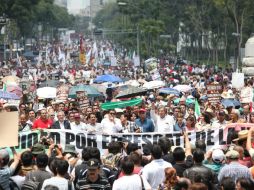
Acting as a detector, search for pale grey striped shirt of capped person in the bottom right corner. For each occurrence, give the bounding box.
[218,162,253,182]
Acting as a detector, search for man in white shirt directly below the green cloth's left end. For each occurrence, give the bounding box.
[101,110,123,134]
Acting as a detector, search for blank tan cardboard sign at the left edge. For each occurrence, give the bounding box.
[0,112,19,148]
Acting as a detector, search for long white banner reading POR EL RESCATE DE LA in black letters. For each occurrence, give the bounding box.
[16,123,254,152]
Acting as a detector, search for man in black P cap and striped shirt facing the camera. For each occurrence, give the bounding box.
[76,158,111,190]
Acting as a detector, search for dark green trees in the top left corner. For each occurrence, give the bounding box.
[0,0,75,45]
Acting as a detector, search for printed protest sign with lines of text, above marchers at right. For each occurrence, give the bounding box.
[206,84,222,103]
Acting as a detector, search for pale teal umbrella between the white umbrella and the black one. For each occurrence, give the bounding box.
[69,84,103,98]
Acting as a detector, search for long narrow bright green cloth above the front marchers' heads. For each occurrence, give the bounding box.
[101,98,142,110]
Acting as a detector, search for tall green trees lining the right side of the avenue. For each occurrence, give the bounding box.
[93,0,254,67]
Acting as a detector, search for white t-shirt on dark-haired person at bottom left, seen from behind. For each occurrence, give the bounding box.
[41,177,74,190]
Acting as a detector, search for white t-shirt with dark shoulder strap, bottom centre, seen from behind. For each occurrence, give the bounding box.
[112,174,151,190]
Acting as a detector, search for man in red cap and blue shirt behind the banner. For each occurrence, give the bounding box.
[135,108,154,132]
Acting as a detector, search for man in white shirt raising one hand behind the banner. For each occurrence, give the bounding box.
[150,103,175,133]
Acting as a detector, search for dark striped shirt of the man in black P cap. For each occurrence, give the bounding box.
[76,176,111,190]
